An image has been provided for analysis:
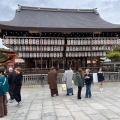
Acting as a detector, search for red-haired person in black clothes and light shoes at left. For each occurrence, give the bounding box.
[13,67,23,107]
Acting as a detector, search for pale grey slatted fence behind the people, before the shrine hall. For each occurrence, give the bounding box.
[23,72,120,87]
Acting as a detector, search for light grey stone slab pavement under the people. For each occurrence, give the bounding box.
[0,82,120,120]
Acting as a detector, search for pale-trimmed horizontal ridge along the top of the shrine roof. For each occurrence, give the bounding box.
[18,5,98,14]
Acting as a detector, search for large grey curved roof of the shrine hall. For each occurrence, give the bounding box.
[0,6,120,31]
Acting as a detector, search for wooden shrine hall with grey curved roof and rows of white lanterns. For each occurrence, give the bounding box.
[0,6,120,70]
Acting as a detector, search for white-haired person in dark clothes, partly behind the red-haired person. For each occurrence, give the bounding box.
[8,67,15,103]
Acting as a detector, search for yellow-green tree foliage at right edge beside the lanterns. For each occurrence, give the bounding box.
[106,45,120,61]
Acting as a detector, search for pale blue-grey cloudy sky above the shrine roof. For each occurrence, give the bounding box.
[0,0,120,47]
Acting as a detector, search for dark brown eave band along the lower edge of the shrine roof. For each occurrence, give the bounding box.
[0,25,120,32]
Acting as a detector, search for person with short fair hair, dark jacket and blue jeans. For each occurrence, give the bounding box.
[84,69,92,98]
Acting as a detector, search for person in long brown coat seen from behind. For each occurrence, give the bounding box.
[48,67,58,97]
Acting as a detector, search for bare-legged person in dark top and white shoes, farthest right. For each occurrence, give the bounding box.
[97,68,104,92]
